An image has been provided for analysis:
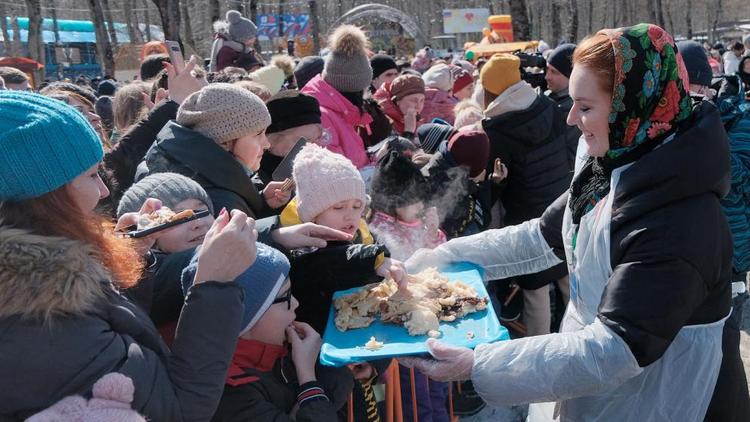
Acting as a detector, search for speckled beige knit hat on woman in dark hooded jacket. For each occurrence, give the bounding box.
[177,83,271,144]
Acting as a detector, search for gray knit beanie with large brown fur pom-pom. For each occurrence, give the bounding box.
[323,25,372,92]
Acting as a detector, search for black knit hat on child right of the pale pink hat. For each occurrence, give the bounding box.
[370,151,428,215]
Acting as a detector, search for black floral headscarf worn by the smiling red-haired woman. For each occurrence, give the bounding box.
[570,23,692,224]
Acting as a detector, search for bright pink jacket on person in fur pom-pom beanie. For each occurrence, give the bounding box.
[302,75,373,169]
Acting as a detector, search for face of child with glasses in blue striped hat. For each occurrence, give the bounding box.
[242,278,299,344]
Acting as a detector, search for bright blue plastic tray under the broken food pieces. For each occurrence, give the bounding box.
[320,263,510,366]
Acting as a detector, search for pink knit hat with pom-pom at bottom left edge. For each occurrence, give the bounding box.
[27,372,146,422]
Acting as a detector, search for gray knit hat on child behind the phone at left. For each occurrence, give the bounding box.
[117,173,214,217]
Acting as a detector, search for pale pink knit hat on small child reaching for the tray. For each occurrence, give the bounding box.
[292,144,367,223]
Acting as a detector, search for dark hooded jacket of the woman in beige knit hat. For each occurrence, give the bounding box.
[136,121,273,218]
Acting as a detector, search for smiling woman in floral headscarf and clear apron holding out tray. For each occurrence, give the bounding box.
[402,24,732,422]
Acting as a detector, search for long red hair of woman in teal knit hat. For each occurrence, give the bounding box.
[0,185,144,289]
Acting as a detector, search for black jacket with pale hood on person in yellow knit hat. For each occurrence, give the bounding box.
[482,81,573,225]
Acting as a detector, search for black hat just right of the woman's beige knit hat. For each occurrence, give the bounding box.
[266,90,320,133]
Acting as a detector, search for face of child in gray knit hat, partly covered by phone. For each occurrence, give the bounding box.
[156,199,214,253]
